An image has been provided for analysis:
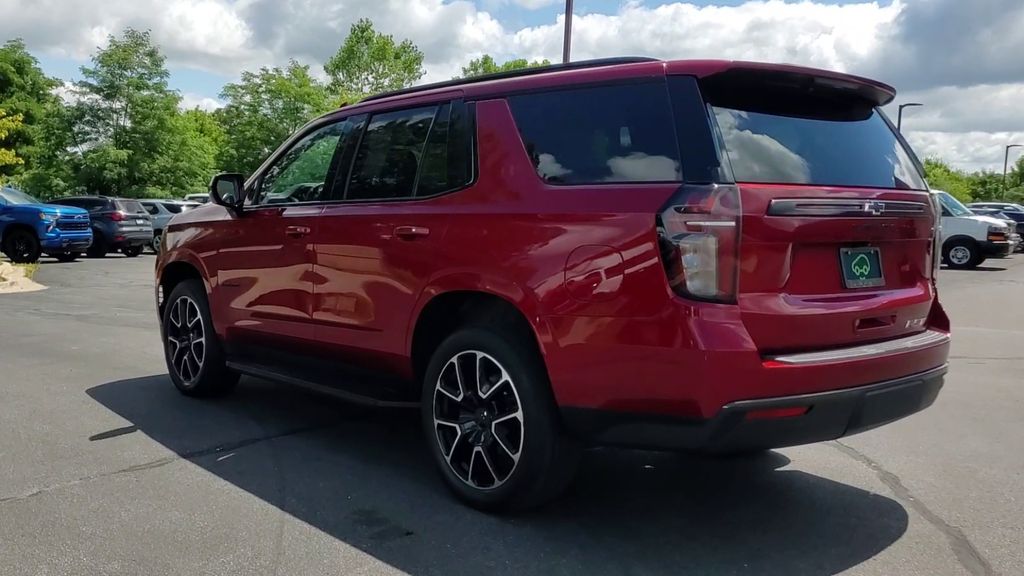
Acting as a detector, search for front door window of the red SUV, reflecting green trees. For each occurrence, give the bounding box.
[253,122,351,204]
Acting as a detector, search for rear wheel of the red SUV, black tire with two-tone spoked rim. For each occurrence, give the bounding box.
[422,327,582,511]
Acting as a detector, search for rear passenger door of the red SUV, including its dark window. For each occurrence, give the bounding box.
[312,101,472,370]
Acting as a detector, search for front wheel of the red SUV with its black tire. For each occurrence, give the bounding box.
[160,280,239,398]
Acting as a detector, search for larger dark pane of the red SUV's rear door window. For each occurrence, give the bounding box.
[345,107,438,200]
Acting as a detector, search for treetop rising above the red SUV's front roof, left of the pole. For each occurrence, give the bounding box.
[324,18,424,102]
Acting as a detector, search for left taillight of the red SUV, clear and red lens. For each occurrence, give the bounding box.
[657,184,741,302]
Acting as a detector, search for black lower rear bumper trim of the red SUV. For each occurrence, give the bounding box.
[562,365,946,452]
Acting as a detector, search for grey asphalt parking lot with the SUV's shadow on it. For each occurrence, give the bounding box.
[0,255,1024,575]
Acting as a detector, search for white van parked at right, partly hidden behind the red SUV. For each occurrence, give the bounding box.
[932,190,1020,269]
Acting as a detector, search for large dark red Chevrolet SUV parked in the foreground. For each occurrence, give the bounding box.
[157,58,949,509]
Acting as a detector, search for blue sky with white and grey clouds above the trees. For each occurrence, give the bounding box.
[0,0,1024,171]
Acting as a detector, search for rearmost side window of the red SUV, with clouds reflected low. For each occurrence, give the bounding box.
[509,82,681,183]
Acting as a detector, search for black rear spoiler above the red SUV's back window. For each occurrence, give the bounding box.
[668,60,896,107]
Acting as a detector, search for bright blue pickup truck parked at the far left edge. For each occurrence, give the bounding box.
[0,188,92,263]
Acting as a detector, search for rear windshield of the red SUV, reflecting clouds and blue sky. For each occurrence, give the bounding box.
[713,107,926,190]
